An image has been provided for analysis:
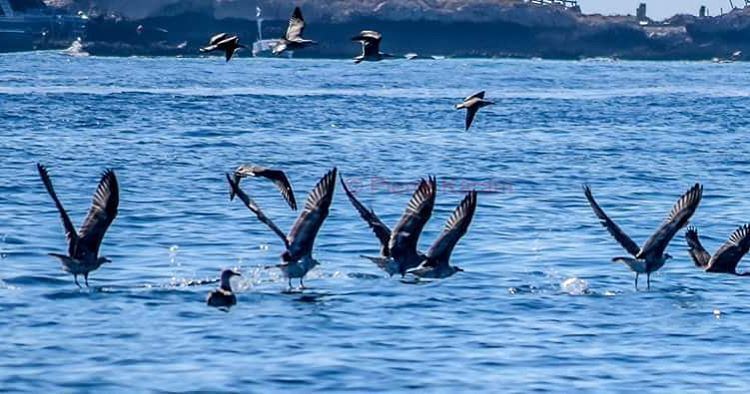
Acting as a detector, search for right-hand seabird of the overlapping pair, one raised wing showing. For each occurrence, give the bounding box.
[407,190,477,279]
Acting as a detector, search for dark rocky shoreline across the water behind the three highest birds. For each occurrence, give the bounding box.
[4,0,750,60]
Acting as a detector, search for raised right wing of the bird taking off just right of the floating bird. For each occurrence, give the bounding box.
[287,167,336,260]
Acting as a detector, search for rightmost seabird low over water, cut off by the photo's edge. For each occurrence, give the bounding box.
[685,224,750,276]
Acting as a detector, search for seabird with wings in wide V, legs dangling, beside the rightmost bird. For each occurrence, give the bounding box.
[583,183,703,290]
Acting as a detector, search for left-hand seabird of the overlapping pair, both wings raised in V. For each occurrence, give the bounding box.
[341,177,437,276]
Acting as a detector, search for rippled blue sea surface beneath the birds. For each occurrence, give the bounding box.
[0,52,750,393]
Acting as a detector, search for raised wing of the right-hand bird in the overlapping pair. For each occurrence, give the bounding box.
[425,190,477,266]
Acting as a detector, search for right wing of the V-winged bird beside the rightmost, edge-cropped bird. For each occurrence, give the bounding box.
[635,183,703,259]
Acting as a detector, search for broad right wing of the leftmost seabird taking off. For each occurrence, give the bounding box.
[78,169,120,254]
